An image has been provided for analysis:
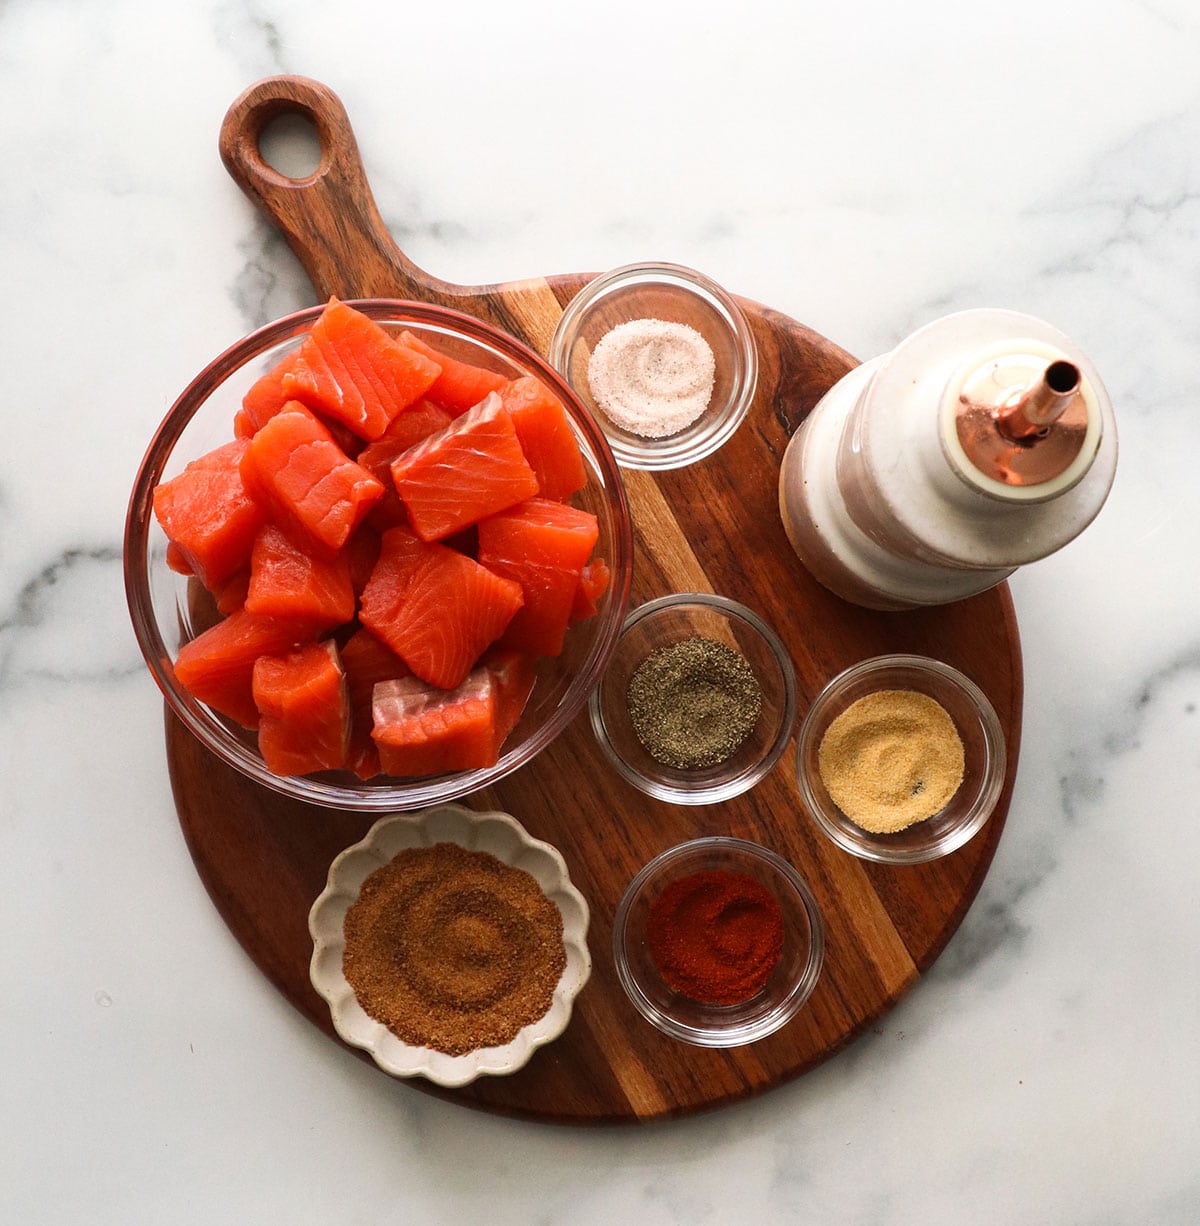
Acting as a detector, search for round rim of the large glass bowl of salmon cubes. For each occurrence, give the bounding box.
[123,298,634,813]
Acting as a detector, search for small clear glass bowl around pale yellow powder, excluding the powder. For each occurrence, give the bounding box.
[796,655,1004,864]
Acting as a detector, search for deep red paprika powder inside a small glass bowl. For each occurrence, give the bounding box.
[646,869,783,1004]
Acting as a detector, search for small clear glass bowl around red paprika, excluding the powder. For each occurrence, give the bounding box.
[613,836,825,1047]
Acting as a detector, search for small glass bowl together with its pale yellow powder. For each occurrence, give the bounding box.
[796,655,1005,864]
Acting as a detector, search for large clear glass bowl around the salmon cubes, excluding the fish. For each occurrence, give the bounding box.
[125,299,632,813]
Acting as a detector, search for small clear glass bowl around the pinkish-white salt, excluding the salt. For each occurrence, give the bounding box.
[549,264,759,471]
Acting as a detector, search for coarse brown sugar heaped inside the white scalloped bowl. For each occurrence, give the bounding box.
[342,842,566,1056]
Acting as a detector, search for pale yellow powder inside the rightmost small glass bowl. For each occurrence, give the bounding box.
[818,690,965,834]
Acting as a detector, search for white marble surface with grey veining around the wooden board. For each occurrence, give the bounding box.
[0,0,1200,1226]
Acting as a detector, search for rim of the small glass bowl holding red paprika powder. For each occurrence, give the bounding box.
[613,835,825,1047]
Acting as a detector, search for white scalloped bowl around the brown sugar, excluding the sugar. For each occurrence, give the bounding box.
[309,804,592,1087]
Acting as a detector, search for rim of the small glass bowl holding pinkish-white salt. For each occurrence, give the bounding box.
[547,260,759,472]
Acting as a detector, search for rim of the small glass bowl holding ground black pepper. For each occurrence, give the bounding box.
[587,592,799,804]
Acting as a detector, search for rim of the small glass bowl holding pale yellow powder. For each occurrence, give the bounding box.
[794,652,1008,864]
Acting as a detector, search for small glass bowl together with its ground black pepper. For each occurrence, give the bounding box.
[588,592,797,804]
